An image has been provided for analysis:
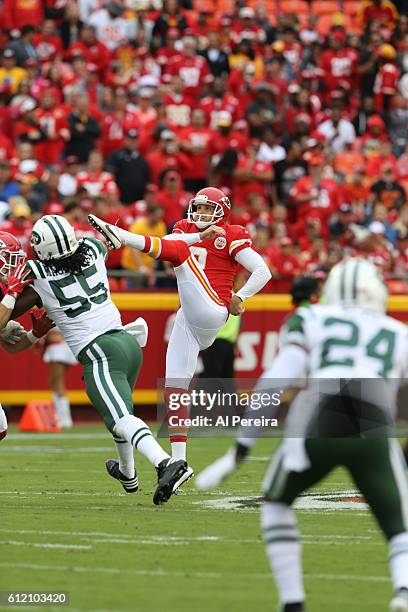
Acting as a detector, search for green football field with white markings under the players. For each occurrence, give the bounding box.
[0,426,391,612]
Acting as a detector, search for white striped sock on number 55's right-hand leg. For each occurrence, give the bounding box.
[113,414,169,467]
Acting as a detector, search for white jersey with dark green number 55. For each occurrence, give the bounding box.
[27,238,122,357]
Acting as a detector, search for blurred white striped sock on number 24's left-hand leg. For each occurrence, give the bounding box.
[261,502,305,604]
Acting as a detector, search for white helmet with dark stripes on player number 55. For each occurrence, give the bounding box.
[31,215,79,261]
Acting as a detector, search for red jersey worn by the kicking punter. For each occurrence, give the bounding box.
[173,219,252,306]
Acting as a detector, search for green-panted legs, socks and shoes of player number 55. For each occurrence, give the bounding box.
[78,330,187,504]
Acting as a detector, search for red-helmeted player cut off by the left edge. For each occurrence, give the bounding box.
[0,232,54,440]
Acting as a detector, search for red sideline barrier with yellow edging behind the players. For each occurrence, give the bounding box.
[0,292,408,405]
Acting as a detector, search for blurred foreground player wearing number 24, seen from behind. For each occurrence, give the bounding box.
[197,258,408,612]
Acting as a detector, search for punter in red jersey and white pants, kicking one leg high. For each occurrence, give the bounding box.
[88,187,271,479]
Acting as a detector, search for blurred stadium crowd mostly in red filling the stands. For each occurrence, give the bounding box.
[0,0,408,292]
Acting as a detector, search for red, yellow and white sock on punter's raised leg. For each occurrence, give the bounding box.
[115,227,191,267]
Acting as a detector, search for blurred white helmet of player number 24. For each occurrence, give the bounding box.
[323,257,388,314]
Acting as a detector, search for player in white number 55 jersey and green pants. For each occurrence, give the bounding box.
[0,215,187,504]
